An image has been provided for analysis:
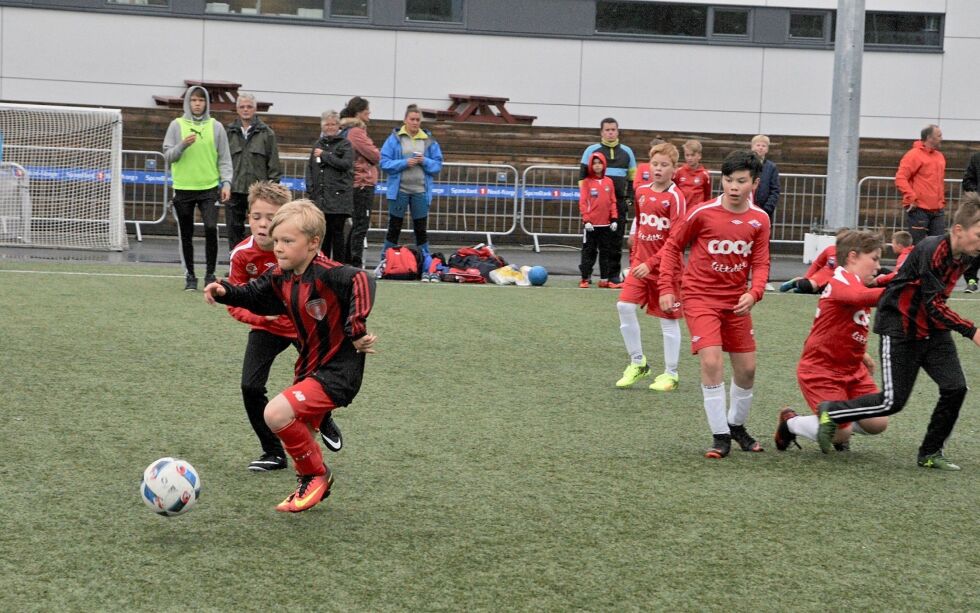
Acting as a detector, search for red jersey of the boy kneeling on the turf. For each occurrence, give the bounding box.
[800,267,885,375]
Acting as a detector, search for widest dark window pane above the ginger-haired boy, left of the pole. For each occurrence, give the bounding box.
[595,0,708,38]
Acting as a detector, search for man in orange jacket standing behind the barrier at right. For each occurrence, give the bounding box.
[895,124,946,244]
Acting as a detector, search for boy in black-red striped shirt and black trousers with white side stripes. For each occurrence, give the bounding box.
[817,194,980,470]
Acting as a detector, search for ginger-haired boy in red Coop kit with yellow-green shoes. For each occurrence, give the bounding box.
[616,143,685,392]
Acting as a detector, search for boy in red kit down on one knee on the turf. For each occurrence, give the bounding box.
[773,230,888,451]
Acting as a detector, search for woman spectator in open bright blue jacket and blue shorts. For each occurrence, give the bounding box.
[378,104,442,271]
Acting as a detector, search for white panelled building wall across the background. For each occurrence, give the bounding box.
[0,0,980,140]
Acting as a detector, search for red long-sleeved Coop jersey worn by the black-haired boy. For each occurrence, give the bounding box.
[660,196,769,310]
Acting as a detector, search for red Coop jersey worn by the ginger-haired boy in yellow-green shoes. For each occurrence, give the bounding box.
[630,183,687,271]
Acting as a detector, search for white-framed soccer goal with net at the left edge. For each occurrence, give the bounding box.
[0,103,128,251]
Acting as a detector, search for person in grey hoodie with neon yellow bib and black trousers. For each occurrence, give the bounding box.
[163,86,232,291]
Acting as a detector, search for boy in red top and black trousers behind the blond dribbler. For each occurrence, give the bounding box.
[228,181,343,472]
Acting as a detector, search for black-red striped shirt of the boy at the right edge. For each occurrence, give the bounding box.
[875,234,977,339]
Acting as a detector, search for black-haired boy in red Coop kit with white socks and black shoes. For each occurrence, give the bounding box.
[660,151,769,458]
